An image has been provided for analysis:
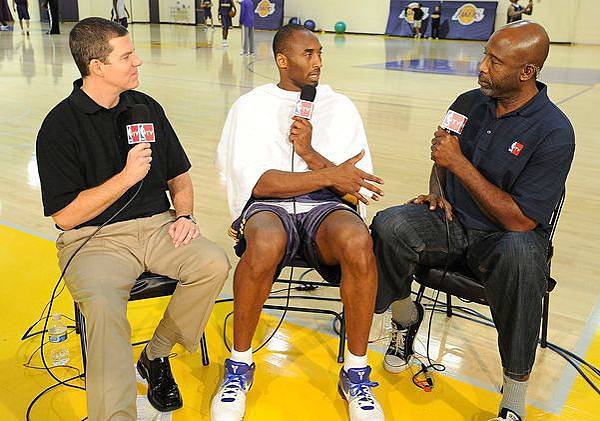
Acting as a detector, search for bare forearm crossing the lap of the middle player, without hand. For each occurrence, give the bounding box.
[252,168,331,198]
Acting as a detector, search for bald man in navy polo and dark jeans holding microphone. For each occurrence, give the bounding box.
[371,21,575,420]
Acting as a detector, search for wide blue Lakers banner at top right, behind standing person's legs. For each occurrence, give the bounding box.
[385,0,498,41]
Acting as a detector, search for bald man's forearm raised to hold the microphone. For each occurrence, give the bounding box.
[453,159,537,231]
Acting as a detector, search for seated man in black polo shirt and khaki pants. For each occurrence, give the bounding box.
[37,18,229,421]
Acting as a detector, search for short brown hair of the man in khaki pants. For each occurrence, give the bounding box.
[69,17,129,77]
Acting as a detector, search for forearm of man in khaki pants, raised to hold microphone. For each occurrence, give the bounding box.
[52,173,133,230]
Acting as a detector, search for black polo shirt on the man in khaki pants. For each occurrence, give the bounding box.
[36,79,191,227]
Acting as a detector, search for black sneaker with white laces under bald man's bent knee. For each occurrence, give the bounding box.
[383,303,425,373]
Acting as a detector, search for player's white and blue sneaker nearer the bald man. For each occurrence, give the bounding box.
[338,366,385,421]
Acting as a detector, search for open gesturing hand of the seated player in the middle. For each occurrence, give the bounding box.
[328,150,384,205]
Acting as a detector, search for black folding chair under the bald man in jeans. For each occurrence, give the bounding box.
[414,190,566,348]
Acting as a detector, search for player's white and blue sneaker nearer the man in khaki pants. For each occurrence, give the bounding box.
[210,359,256,421]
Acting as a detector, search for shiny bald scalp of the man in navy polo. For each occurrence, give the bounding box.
[490,20,550,69]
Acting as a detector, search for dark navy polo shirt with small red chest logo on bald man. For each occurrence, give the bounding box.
[445,82,575,231]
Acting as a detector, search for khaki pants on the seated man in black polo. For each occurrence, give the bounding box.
[56,212,230,421]
